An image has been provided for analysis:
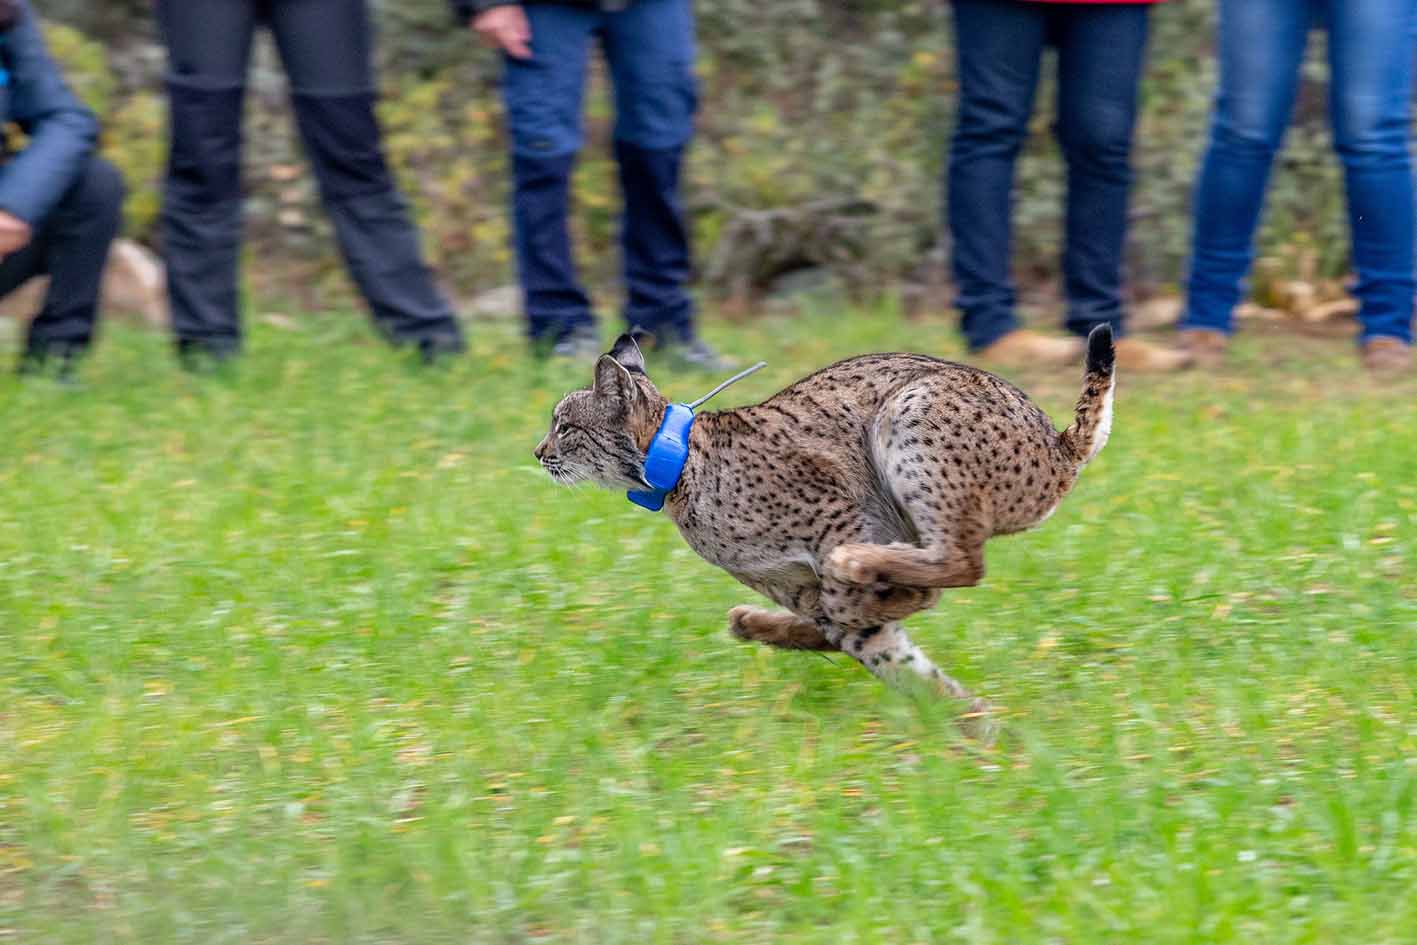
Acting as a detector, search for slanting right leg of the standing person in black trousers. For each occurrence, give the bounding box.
[271,0,463,357]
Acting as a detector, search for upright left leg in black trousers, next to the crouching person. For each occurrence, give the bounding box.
[157,0,258,356]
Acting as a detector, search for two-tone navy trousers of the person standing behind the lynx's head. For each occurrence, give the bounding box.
[503,0,697,340]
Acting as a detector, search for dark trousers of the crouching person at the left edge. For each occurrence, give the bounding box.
[0,157,123,361]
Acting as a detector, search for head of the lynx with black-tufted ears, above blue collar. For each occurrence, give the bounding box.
[536,334,666,489]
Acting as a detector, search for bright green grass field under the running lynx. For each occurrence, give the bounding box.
[0,313,1417,945]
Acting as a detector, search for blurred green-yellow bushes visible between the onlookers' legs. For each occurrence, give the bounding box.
[47,0,1348,298]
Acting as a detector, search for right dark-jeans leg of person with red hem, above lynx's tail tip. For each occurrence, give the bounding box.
[1056,3,1149,337]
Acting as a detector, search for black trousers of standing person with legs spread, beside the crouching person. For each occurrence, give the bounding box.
[157,0,462,354]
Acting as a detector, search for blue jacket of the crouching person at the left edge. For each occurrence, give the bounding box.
[0,0,98,227]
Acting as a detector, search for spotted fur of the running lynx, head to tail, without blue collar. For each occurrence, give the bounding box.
[536,327,1115,736]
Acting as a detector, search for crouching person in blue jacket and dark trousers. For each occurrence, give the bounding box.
[0,0,123,373]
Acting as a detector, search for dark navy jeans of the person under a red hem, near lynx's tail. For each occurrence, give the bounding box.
[947,0,1148,349]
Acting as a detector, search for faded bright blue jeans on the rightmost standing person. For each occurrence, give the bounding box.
[1182,0,1417,341]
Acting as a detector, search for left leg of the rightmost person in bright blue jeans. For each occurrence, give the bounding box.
[1180,0,1314,333]
